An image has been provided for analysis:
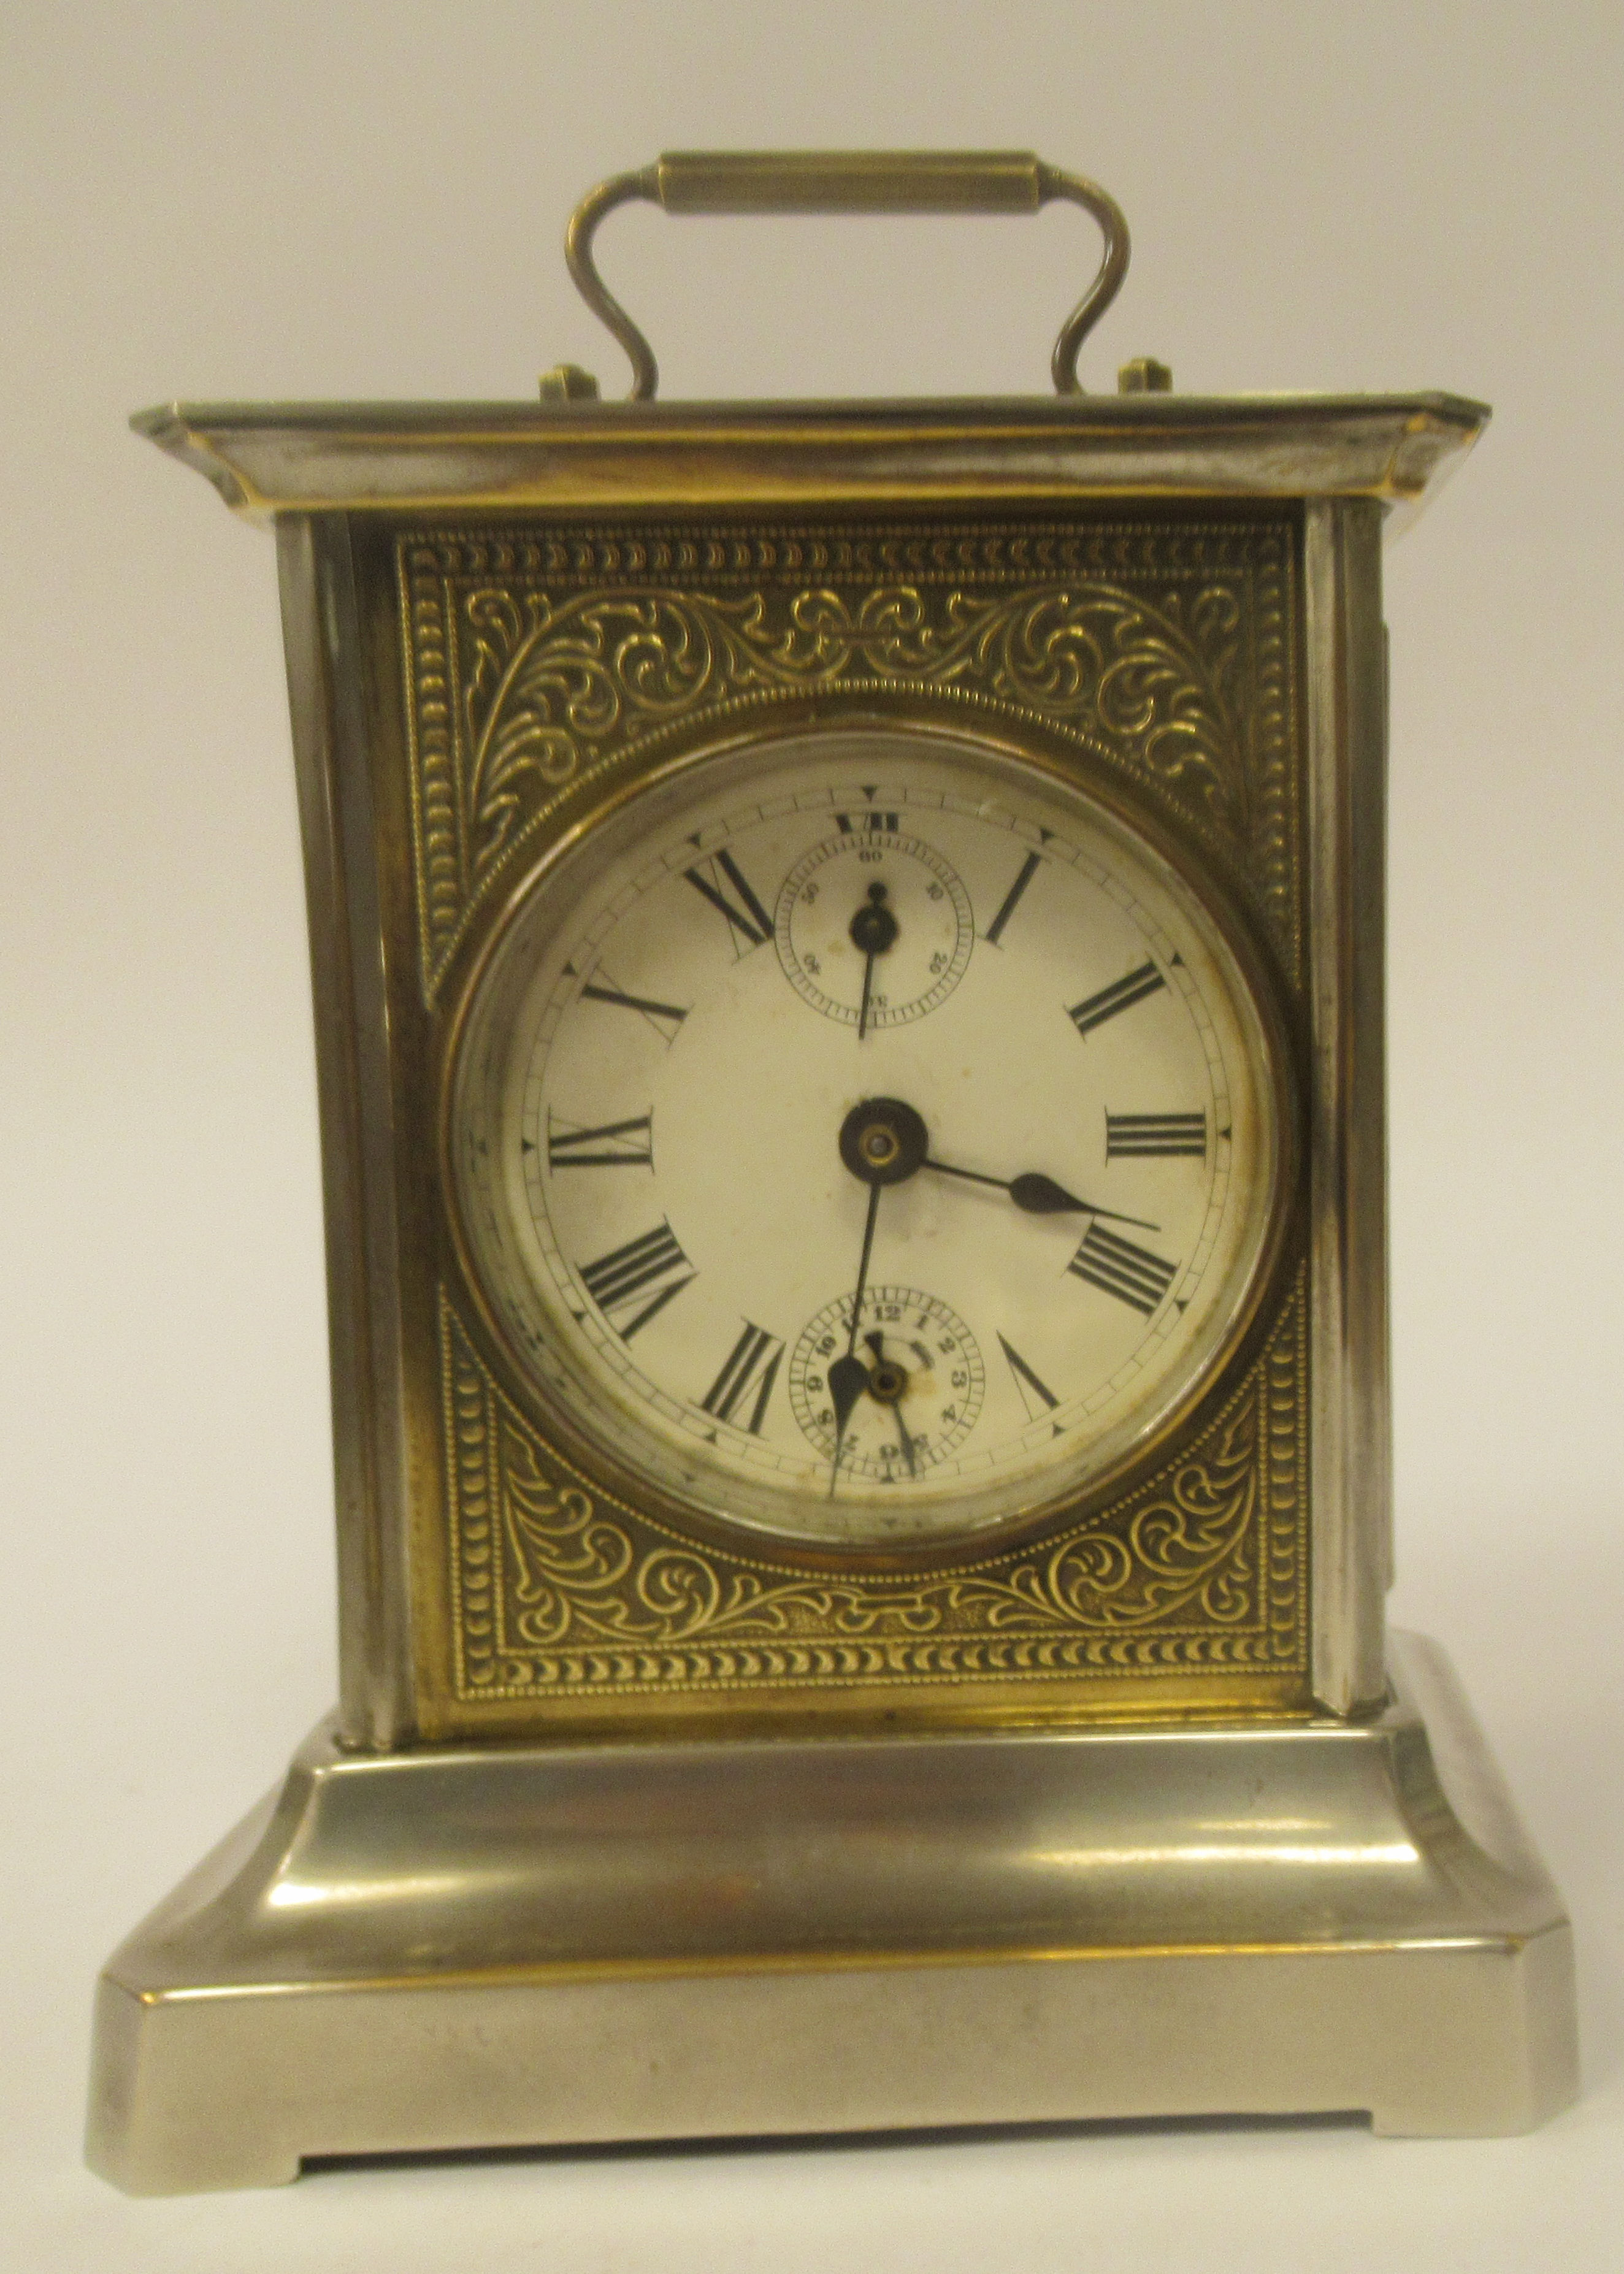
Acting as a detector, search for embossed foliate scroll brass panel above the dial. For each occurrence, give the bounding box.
[398,523,1297,992]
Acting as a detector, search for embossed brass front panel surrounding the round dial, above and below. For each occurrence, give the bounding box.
[382,507,1308,1735]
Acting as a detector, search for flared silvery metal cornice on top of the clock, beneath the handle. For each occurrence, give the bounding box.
[129,391,1490,532]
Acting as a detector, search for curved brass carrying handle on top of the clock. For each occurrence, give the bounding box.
[564,150,1128,402]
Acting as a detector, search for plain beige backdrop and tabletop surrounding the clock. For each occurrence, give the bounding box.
[0,0,1624,2274]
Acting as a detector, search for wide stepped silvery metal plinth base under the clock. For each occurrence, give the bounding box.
[89,1635,1576,2194]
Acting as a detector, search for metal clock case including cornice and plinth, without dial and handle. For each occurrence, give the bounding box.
[89,160,1574,2192]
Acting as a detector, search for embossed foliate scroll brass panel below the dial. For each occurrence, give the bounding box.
[441,1287,1306,1699]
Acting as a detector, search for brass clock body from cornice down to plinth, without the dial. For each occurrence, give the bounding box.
[157,409,1401,1747]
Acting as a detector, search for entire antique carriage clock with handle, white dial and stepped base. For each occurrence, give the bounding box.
[89,152,1574,2192]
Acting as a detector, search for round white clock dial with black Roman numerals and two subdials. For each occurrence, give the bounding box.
[448,730,1283,1549]
